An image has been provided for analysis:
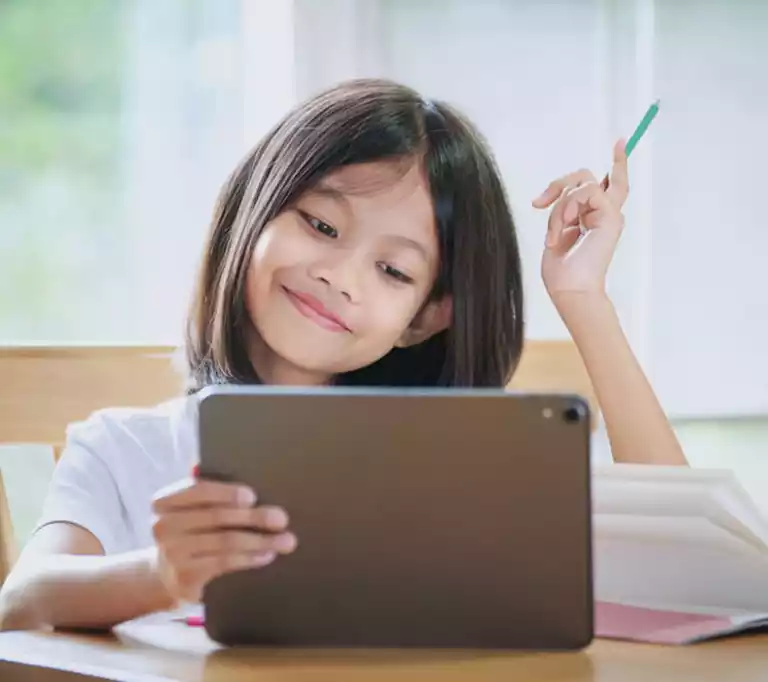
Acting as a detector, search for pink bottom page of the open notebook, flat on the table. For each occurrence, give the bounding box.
[595,602,768,644]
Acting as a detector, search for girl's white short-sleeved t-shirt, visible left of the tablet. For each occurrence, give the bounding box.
[37,397,199,554]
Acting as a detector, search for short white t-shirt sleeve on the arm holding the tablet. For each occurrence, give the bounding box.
[35,413,128,554]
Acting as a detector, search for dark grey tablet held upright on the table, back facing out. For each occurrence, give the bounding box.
[199,387,593,649]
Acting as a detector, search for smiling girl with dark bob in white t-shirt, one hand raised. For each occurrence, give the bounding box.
[0,80,685,628]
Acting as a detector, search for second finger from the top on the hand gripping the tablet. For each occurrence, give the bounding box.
[152,506,288,543]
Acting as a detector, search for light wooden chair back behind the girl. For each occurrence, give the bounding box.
[0,341,596,584]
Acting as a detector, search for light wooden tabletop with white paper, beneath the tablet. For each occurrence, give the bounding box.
[0,615,768,682]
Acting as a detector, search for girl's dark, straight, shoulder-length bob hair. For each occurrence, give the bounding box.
[185,79,524,393]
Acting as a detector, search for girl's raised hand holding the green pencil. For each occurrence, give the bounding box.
[533,140,629,303]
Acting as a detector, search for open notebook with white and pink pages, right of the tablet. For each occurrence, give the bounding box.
[593,464,768,643]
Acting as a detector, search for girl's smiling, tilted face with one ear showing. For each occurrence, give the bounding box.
[245,162,450,384]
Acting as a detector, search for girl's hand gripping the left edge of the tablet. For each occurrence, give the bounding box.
[152,478,296,602]
